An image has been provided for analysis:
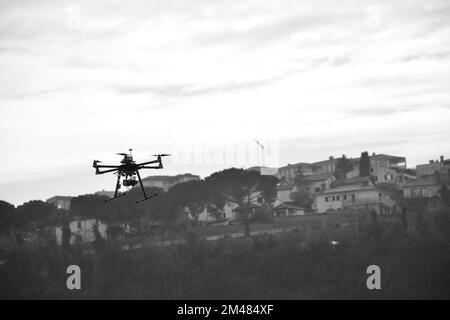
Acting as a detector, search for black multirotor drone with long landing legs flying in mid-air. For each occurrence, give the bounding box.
[92,149,170,203]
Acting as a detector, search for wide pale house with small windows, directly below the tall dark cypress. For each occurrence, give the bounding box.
[313,178,395,213]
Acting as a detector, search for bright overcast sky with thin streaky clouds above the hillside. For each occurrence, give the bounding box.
[0,0,450,205]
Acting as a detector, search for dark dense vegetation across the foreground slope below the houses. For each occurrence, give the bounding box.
[0,208,450,299]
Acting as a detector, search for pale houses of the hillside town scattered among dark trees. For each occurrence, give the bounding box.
[31,152,450,242]
